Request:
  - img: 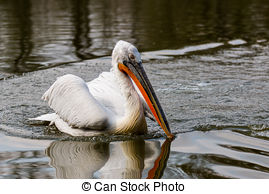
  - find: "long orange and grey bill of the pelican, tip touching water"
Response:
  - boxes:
[118,61,174,138]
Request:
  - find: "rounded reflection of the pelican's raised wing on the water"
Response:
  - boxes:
[46,141,109,178]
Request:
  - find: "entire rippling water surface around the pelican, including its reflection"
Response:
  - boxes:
[0,0,269,178]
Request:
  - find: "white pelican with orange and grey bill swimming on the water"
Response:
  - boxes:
[35,40,173,138]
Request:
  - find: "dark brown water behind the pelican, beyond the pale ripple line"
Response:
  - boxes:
[0,0,269,76]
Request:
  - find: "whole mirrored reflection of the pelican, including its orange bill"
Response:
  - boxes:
[46,139,171,178]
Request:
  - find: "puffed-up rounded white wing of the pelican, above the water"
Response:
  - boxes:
[42,74,109,129]
